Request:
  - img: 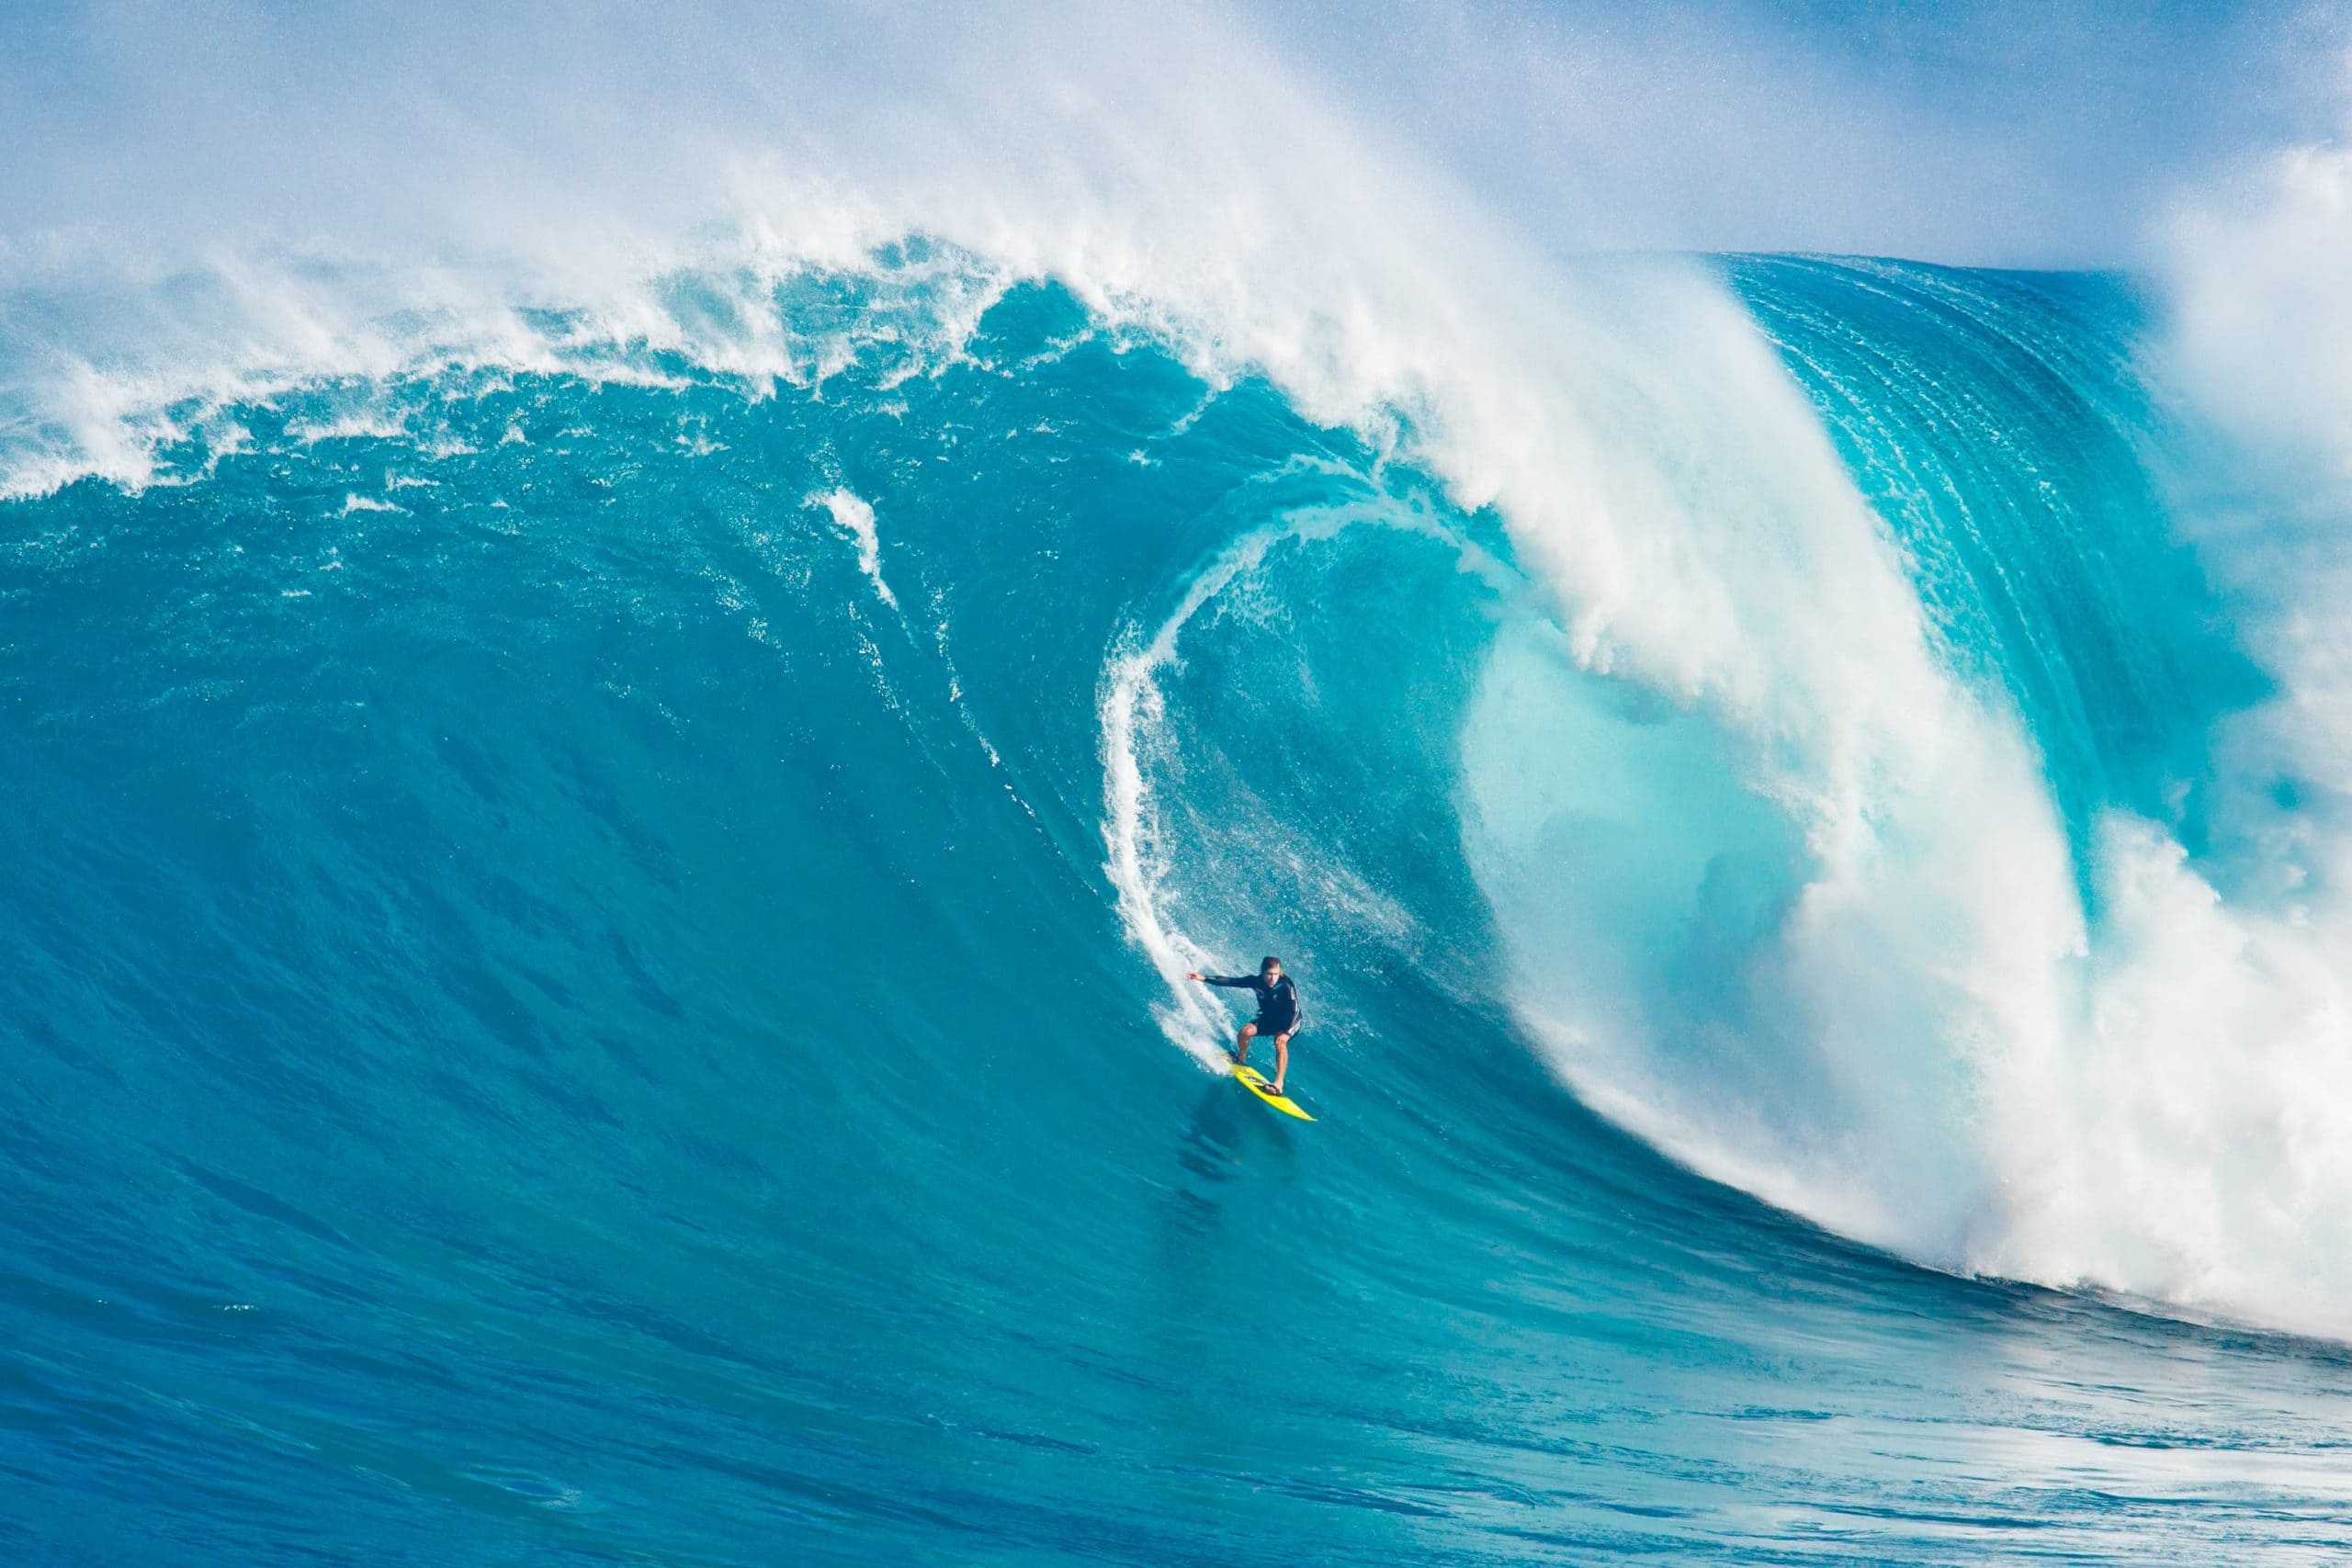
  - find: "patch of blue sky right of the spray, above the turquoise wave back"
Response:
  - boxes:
[1289,0,2352,265]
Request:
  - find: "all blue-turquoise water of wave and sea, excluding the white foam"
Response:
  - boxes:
[0,259,2352,1565]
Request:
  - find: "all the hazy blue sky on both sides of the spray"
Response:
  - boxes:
[0,0,2347,265]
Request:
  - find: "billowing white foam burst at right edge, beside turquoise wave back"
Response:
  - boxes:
[1947,138,2352,1336]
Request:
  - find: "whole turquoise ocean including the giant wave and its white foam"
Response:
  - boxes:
[0,237,2352,1568]
